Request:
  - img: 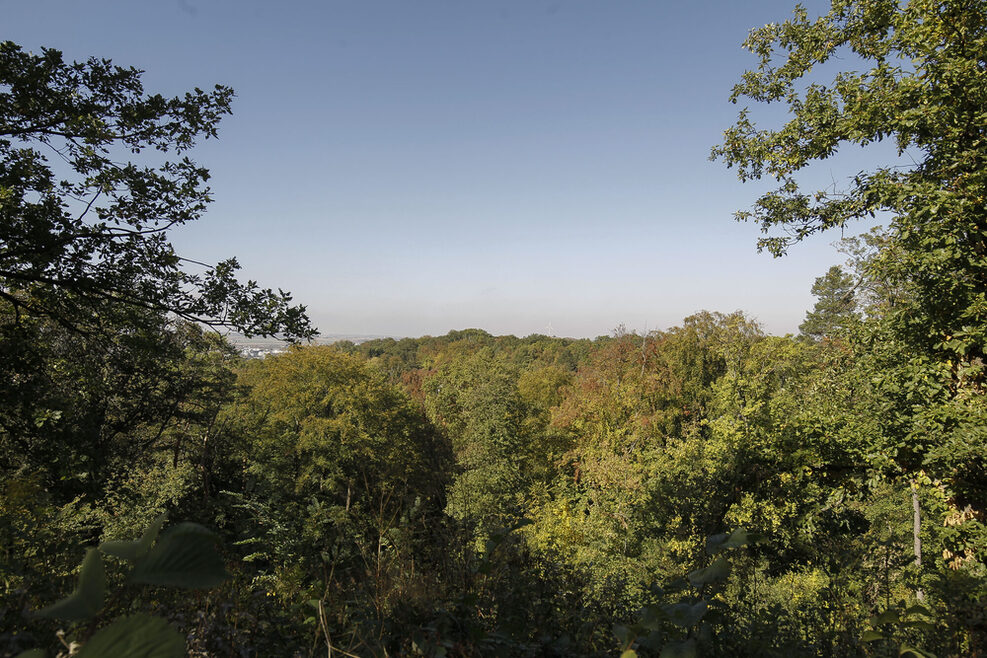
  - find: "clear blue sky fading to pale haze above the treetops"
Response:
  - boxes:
[0,0,888,337]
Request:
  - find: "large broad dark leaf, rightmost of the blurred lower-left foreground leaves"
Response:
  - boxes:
[130,523,228,589]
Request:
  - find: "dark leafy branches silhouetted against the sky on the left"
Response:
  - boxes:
[0,41,315,338]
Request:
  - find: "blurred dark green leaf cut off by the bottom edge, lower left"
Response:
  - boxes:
[76,614,185,658]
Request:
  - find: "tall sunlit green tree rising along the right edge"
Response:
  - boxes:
[713,0,987,642]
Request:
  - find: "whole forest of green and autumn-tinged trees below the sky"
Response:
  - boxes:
[0,0,987,658]
